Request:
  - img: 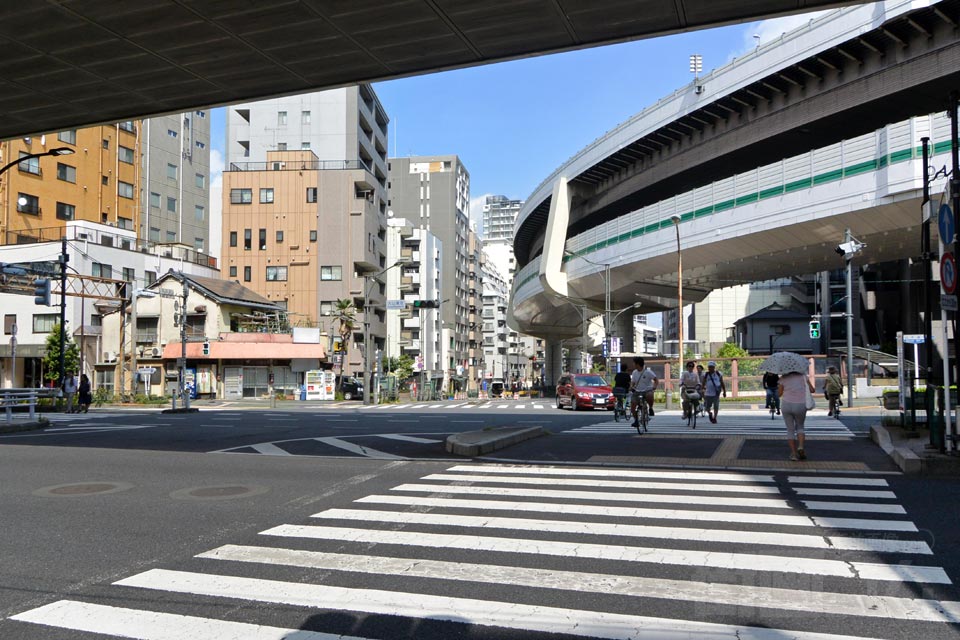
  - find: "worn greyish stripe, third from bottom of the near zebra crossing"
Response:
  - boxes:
[206,545,960,623]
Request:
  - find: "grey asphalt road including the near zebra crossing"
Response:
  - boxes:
[0,401,960,640]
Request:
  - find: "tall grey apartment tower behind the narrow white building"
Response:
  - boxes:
[388,155,470,389]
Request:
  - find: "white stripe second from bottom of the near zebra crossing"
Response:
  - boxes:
[115,569,892,640]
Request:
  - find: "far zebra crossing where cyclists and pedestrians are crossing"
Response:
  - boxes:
[564,409,857,438]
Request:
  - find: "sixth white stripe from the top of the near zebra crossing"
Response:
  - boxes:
[261,524,952,584]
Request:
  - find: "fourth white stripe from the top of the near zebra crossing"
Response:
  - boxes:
[355,495,917,532]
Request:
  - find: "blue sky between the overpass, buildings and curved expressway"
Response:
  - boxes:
[211,9,813,228]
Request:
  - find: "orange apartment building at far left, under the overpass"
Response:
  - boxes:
[0,121,143,244]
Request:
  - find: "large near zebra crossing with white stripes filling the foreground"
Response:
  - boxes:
[11,464,960,640]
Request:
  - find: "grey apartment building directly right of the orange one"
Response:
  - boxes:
[138,110,212,253]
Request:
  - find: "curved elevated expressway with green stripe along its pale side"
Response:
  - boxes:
[511,0,960,366]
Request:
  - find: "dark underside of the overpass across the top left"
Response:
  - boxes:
[0,0,862,139]
